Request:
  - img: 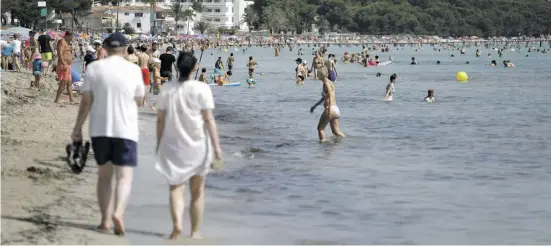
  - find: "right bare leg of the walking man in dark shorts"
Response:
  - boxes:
[111,165,133,236]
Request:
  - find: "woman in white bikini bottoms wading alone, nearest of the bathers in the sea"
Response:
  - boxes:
[312,67,344,142]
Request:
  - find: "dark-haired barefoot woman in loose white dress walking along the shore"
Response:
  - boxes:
[155,53,222,239]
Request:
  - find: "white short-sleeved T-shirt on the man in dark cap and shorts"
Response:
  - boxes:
[81,56,145,142]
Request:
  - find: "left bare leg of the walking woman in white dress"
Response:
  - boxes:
[169,184,185,240]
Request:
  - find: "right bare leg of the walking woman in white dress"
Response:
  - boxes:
[189,175,205,239]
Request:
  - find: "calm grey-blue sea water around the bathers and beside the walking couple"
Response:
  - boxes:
[118,44,551,244]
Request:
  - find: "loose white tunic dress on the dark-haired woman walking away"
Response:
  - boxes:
[155,80,214,185]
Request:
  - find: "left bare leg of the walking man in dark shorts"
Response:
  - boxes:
[96,162,113,232]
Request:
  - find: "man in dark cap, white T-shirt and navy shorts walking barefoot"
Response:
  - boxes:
[72,32,145,235]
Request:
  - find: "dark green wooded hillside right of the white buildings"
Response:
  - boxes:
[244,0,551,37]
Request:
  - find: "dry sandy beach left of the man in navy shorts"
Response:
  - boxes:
[1,72,129,244]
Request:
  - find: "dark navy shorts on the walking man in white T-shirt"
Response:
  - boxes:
[92,137,138,167]
